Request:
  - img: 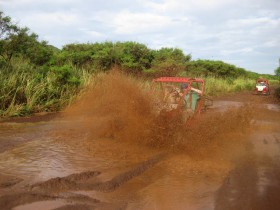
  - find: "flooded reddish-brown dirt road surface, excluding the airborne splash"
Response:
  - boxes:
[0,90,280,210]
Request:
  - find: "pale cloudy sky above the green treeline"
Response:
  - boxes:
[0,0,280,74]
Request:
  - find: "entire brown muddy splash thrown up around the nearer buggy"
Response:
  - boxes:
[62,72,252,158]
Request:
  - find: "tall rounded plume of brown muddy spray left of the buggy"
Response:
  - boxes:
[62,72,154,144]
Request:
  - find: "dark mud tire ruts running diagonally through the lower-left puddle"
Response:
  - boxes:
[0,153,168,210]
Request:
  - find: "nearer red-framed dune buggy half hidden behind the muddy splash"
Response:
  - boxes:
[153,77,213,124]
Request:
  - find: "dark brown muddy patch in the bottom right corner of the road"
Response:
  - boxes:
[215,134,280,210]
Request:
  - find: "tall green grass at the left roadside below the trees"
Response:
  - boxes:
[0,59,92,117]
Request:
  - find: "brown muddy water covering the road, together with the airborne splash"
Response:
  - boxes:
[0,74,280,210]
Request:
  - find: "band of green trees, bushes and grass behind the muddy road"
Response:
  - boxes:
[0,11,279,117]
